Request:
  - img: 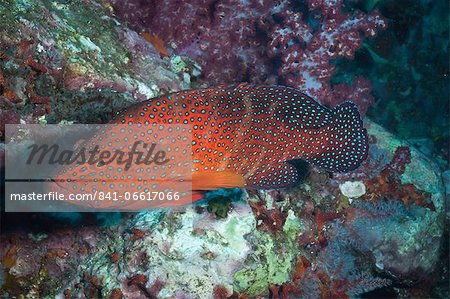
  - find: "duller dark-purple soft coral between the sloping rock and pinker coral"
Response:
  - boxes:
[108,0,283,84]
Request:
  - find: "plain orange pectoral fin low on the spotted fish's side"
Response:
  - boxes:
[192,171,245,190]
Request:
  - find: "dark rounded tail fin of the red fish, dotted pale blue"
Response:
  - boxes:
[307,101,369,172]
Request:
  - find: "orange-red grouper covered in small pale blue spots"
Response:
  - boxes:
[49,84,368,209]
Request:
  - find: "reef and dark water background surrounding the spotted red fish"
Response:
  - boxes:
[0,0,450,298]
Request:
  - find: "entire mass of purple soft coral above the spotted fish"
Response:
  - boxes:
[107,0,386,114]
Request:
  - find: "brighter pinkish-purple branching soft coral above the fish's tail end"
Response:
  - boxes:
[269,0,386,114]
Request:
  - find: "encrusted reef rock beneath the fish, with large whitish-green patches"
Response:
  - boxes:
[0,122,445,298]
